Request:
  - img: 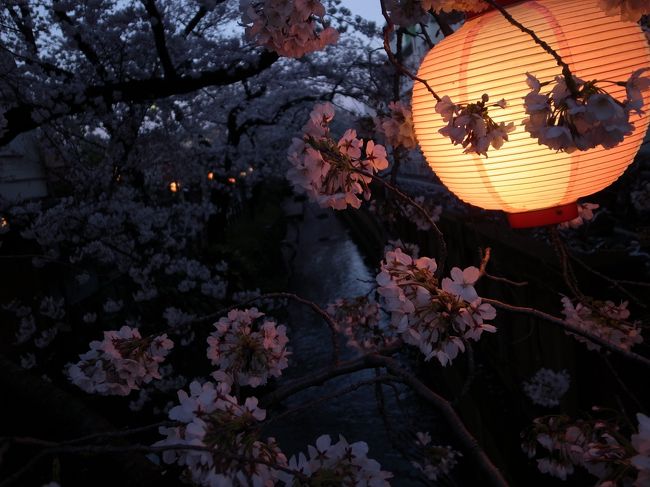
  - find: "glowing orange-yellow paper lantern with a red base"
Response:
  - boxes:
[412,0,650,227]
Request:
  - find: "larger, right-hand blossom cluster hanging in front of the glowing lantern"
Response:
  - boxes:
[524,68,650,153]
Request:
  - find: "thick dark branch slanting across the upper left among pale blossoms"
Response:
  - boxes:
[0,51,278,147]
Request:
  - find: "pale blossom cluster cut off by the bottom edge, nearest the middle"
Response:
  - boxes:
[277,435,393,487]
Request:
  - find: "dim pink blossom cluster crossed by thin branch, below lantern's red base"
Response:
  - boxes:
[562,296,643,350]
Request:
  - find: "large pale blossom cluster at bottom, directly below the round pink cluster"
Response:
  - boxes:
[154,381,286,487]
